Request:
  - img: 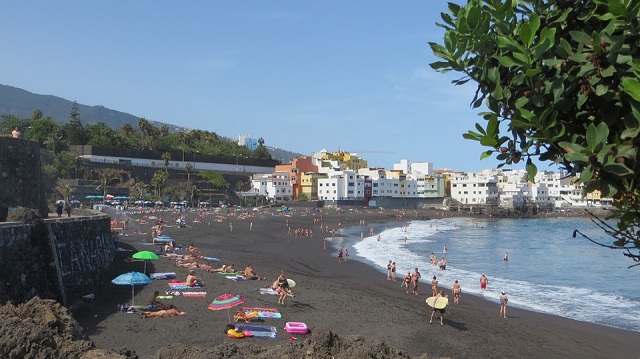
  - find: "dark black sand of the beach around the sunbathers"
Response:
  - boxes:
[73,209,640,358]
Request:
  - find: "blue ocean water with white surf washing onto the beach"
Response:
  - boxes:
[332,218,640,331]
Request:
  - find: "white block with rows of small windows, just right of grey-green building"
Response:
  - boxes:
[450,173,500,205]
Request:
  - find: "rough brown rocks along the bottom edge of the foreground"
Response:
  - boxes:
[0,297,436,359]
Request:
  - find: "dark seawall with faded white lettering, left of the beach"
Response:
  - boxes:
[0,215,115,305]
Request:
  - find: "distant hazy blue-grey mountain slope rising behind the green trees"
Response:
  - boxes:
[0,85,300,163]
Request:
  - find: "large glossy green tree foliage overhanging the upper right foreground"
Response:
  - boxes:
[430,0,640,261]
